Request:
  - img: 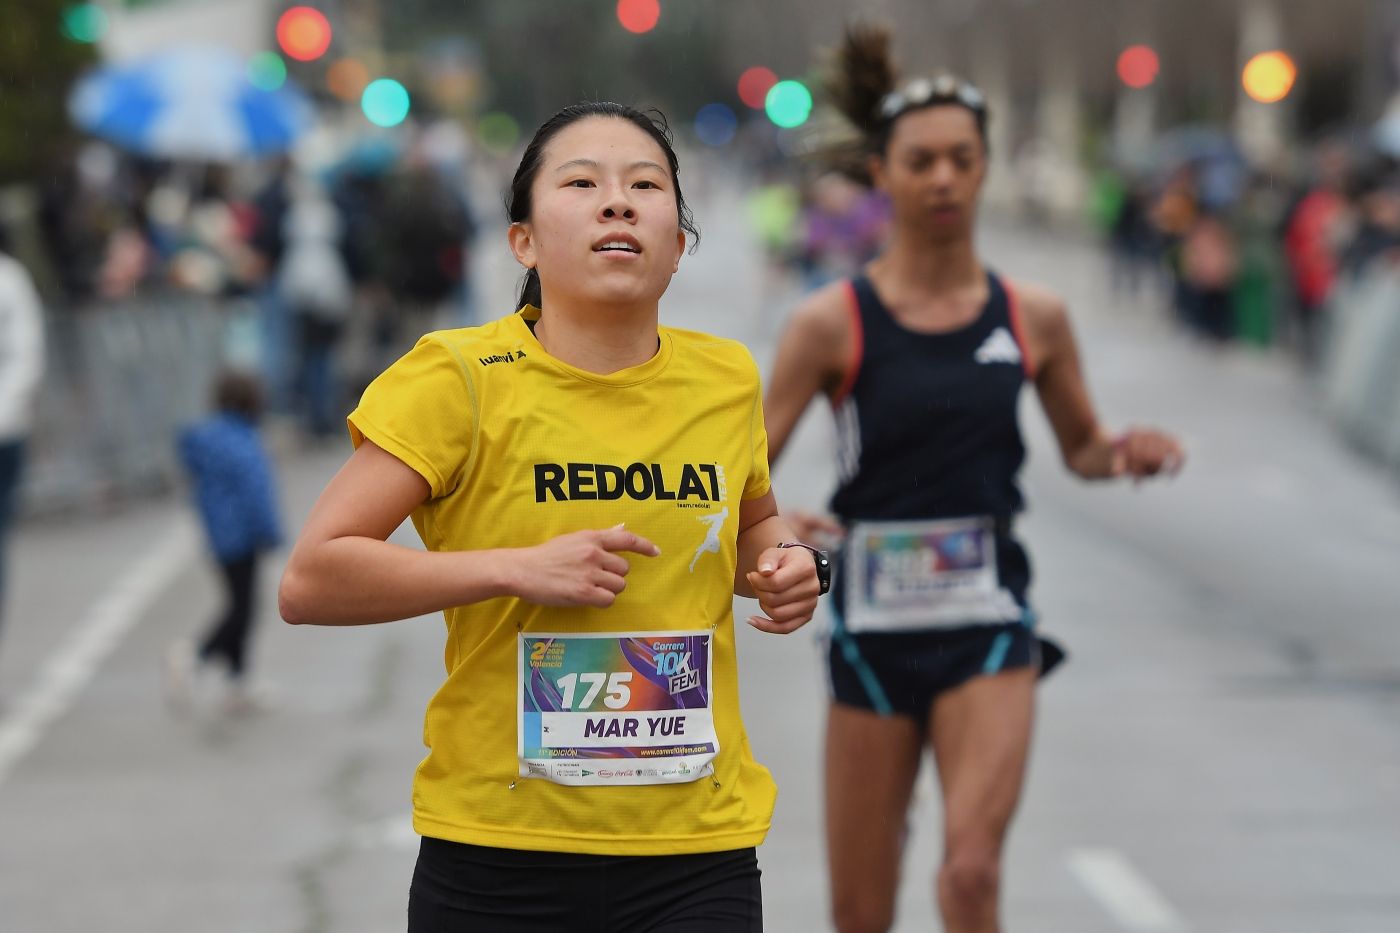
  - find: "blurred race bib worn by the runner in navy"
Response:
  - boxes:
[843,517,1022,632]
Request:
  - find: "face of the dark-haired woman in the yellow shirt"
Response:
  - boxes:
[510,116,686,304]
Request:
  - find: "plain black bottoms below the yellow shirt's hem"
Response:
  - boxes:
[409,836,763,933]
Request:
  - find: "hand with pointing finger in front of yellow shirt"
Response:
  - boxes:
[508,525,661,609]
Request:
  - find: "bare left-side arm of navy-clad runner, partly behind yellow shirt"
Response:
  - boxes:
[763,282,854,464]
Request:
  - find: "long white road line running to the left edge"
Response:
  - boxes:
[0,520,197,785]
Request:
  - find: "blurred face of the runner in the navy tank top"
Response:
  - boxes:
[871,105,987,241]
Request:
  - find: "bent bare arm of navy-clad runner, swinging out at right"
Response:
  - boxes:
[1018,286,1184,479]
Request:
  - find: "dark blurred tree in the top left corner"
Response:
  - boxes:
[0,0,97,185]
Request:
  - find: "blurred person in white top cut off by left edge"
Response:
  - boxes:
[0,218,43,652]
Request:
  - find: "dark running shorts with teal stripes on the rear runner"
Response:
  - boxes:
[827,622,1064,728]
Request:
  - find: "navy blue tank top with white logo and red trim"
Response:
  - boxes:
[832,272,1030,527]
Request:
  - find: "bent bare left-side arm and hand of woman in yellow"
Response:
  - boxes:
[277,441,658,625]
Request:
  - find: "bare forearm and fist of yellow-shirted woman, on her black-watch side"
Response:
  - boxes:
[734,489,822,635]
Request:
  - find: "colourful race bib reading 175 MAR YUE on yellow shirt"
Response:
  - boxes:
[518,632,720,786]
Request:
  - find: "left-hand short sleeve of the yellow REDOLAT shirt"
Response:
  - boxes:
[347,335,479,499]
